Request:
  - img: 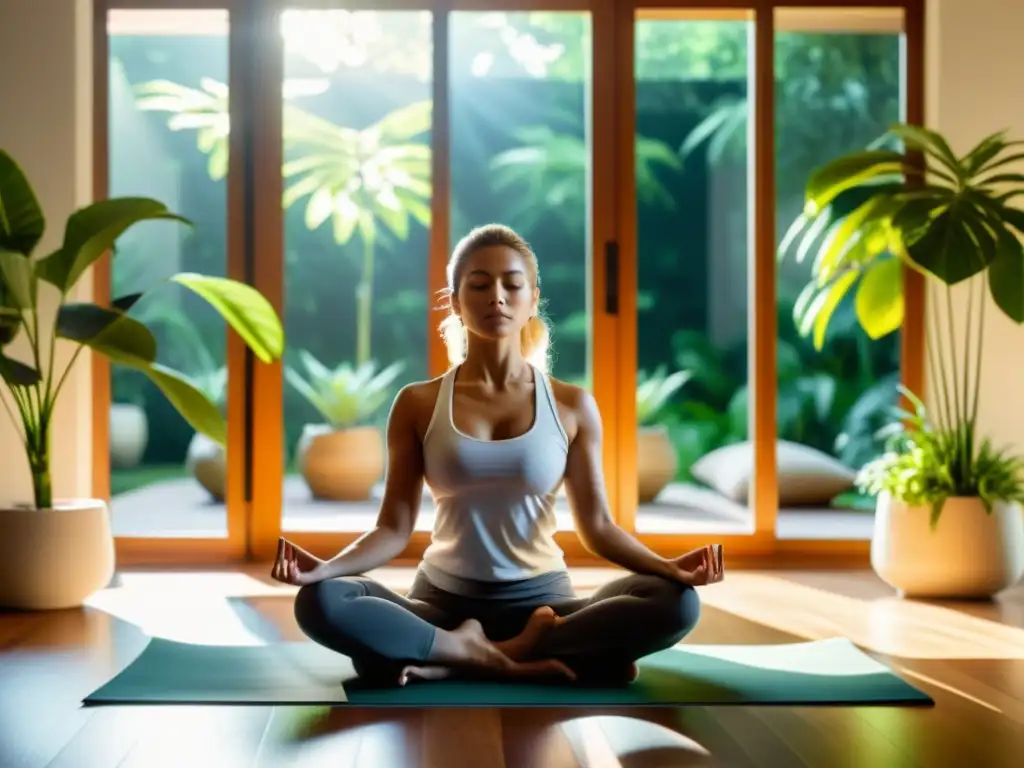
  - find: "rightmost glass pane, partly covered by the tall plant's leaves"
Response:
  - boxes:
[775,9,903,540]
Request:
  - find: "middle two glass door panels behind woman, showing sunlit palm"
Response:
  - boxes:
[254,0,615,565]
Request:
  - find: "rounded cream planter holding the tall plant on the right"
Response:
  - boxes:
[871,495,1024,599]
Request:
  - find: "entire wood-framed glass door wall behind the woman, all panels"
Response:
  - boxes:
[95,0,923,559]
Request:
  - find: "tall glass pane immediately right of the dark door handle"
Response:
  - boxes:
[635,9,754,534]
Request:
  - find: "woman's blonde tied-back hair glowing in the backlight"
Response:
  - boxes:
[440,224,551,373]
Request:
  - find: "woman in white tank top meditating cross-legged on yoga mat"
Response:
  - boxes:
[272,225,722,685]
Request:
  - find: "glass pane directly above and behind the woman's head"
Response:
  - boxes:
[448,11,592,529]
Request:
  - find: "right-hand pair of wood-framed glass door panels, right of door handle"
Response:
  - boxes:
[617,0,923,553]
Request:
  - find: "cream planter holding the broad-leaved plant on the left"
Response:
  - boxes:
[0,499,114,610]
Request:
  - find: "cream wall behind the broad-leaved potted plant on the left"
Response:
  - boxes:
[0,0,92,506]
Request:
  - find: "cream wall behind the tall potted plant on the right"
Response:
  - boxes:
[926,0,1024,450]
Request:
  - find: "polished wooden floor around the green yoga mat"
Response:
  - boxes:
[0,569,1024,768]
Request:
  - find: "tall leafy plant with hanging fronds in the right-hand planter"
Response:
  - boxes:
[780,124,1024,519]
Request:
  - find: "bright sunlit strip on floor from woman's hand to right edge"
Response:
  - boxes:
[701,572,1024,659]
